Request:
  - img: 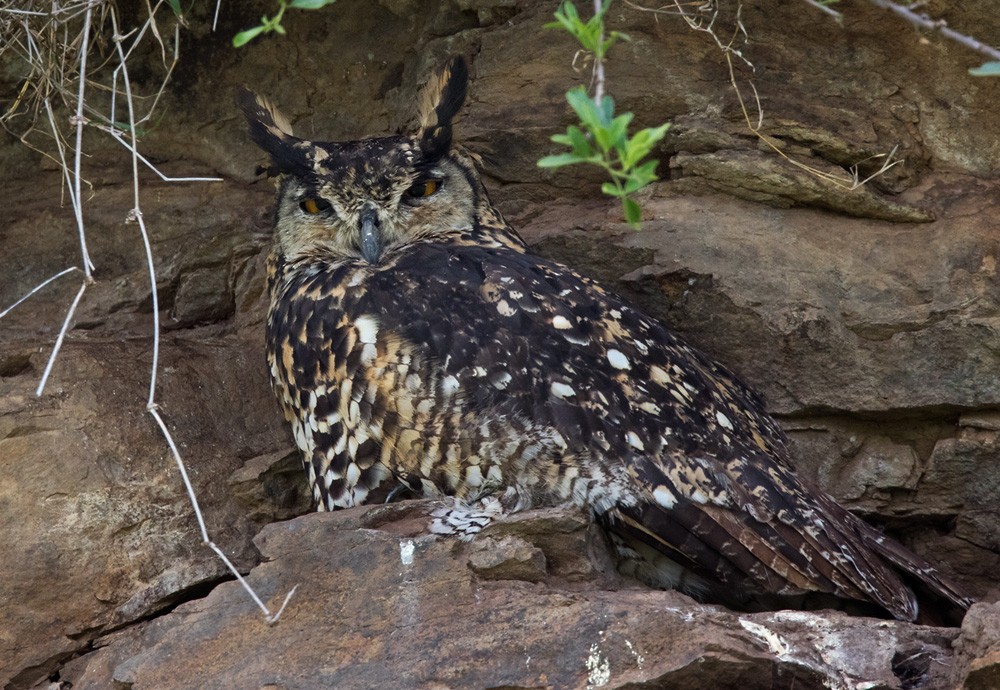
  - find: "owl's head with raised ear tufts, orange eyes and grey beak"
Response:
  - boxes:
[238,57,482,264]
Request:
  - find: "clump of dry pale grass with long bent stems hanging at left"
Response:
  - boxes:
[0,0,295,623]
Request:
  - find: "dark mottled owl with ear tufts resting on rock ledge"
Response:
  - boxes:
[239,58,971,620]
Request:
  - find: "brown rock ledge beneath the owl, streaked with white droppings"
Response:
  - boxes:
[54,502,956,690]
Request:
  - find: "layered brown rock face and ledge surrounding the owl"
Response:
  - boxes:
[0,0,1000,690]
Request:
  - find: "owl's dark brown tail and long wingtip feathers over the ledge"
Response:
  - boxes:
[605,486,972,622]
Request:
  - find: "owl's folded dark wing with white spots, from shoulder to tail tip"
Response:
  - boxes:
[334,238,968,620]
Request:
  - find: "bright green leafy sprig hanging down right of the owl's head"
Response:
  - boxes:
[538,0,670,229]
